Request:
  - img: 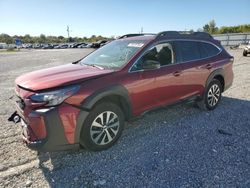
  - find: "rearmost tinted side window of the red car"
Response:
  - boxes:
[199,42,220,58]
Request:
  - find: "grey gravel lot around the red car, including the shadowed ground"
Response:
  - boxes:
[0,49,250,187]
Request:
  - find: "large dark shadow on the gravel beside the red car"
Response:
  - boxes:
[38,97,250,187]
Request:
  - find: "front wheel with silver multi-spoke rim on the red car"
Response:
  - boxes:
[80,102,124,151]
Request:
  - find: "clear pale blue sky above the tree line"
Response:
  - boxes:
[0,0,250,37]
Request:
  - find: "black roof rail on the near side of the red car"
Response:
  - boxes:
[155,31,213,39]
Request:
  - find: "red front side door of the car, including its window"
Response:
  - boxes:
[129,42,181,113]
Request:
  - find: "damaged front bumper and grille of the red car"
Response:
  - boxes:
[8,86,89,151]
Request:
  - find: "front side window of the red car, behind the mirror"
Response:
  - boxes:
[131,43,174,71]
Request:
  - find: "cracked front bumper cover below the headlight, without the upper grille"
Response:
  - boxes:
[9,104,88,151]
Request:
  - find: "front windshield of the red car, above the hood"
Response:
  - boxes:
[80,40,146,69]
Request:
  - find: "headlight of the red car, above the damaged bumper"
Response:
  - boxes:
[30,85,80,106]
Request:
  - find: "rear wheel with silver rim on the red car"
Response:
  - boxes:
[197,79,222,110]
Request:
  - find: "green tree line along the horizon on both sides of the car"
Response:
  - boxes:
[0,20,250,44]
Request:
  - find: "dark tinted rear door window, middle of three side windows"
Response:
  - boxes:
[176,41,200,62]
